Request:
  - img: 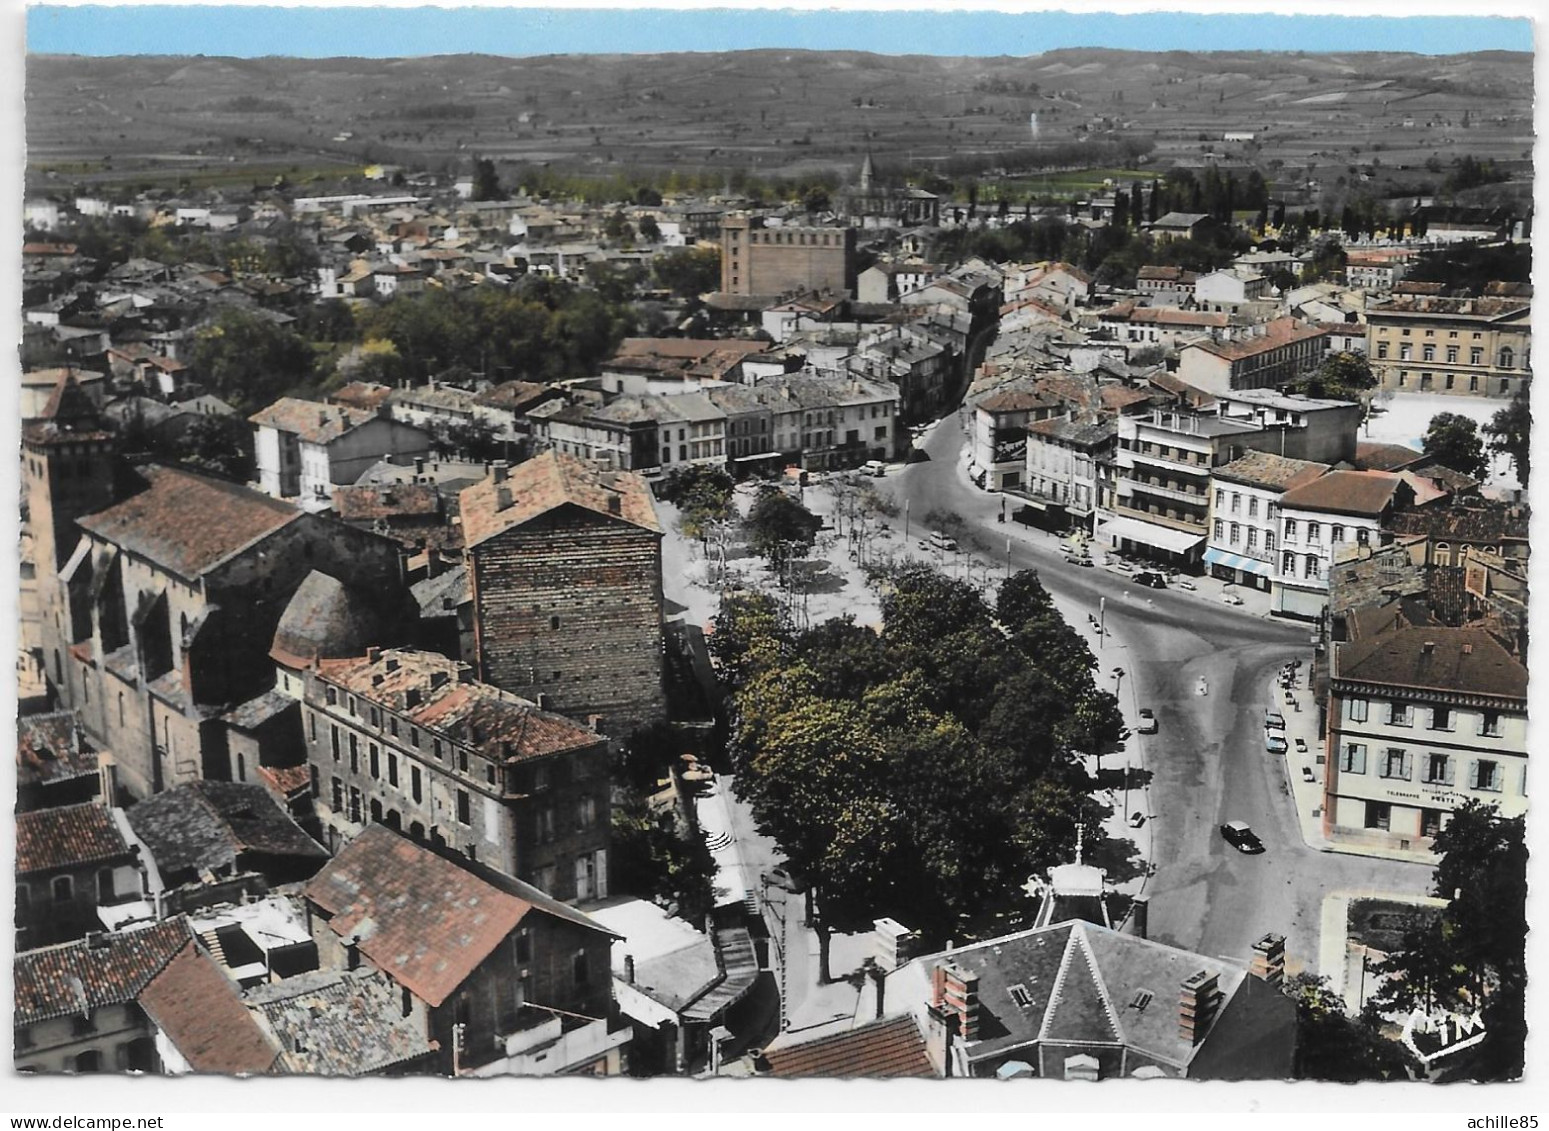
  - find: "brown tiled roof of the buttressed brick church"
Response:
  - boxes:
[79,465,302,581]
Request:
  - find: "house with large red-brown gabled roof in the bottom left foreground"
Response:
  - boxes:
[305,824,629,1075]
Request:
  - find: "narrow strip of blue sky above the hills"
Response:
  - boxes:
[26,5,1532,57]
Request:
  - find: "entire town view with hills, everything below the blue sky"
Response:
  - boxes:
[14,42,1534,1081]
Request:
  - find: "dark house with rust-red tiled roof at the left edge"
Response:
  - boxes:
[15,801,141,950]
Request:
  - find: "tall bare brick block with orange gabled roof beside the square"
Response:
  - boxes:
[460,452,666,736]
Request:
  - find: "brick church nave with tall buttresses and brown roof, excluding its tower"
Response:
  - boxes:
[65,466,403,798]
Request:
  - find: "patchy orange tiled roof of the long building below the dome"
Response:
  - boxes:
[318,648,606,762]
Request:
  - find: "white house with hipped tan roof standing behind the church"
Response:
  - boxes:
[248,397,431,505]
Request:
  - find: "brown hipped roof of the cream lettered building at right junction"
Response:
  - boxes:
[1335,626,1527,705]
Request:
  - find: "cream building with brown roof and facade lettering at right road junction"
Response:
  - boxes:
[1323,617,1527,851]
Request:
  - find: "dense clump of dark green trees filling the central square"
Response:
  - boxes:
[711,567,1126,976]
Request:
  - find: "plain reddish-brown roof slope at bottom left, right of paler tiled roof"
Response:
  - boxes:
[139,939,279,1075]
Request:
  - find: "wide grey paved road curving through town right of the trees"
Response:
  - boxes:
[878,418,1430,968]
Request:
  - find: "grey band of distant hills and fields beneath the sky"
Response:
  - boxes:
[26,50,1534,190]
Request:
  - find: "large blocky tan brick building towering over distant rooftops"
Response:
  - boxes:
[720,214,855,294]
